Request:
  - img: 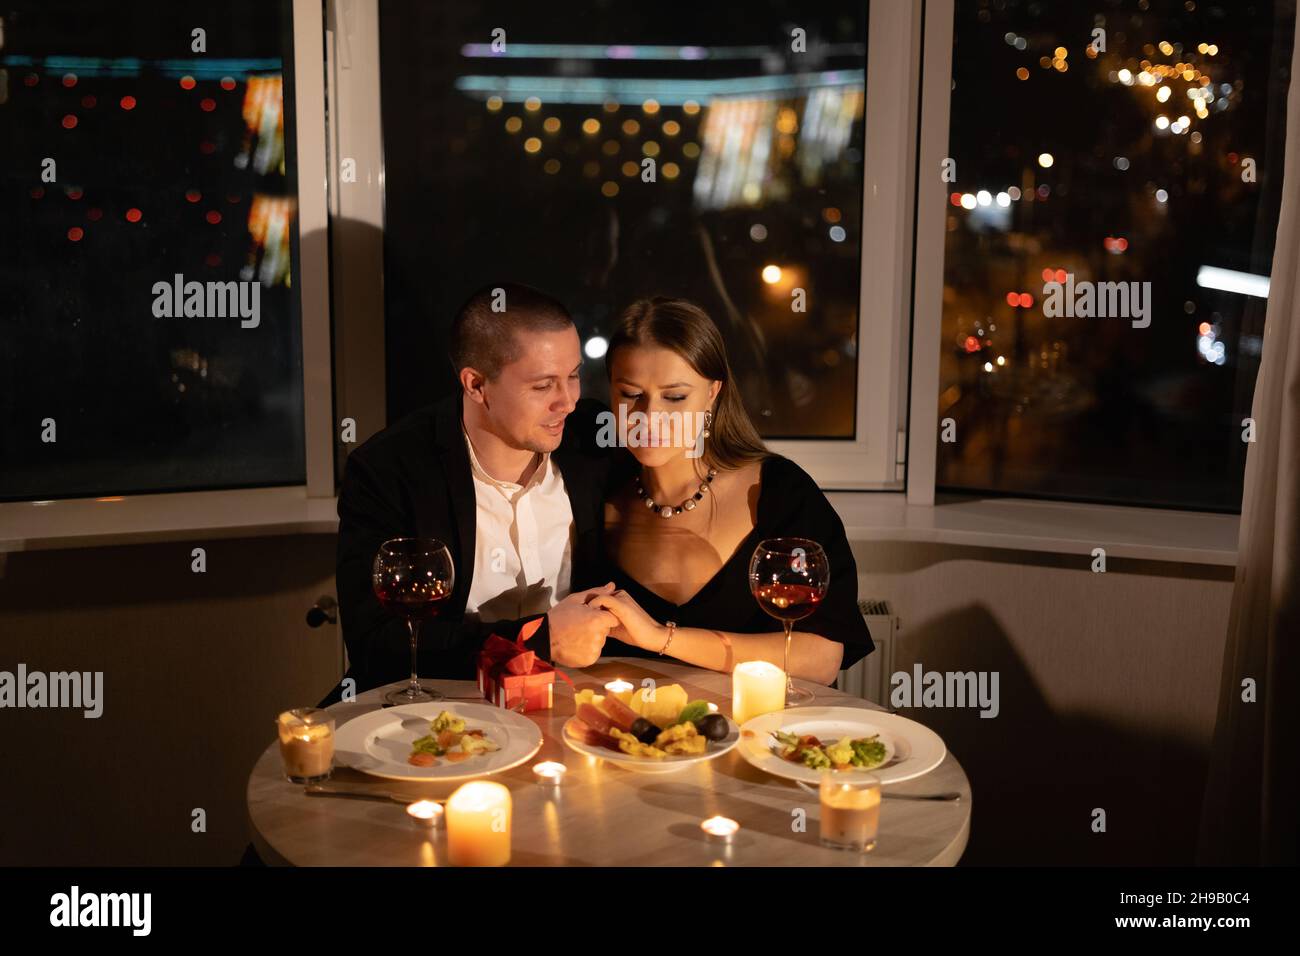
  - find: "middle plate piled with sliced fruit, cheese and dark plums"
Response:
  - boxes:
[564,684,740,774]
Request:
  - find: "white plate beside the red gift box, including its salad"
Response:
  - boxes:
[334,701,542,780]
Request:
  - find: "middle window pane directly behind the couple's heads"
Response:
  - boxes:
[380,1,873,442]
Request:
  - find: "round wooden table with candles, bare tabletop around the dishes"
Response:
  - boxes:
[248,658,971,866]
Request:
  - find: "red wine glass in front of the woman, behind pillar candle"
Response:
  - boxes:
[749,537,831,706]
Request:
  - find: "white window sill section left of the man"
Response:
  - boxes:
[0,485,338,553]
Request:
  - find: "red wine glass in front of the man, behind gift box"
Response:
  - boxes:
[371,537,456,704]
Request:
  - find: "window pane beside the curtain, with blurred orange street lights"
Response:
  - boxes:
[936,0,1295,511]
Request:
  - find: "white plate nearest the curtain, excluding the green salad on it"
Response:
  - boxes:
[740,708,948,783]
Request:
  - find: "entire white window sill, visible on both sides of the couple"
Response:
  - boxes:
[0,486,1239,567]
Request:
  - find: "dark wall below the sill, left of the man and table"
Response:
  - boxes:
[0,535,342,865]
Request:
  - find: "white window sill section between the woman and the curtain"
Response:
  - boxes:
[827,492,1240,567]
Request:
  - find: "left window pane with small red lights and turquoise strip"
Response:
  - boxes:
[0,0,306,501]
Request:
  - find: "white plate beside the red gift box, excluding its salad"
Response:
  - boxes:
[334,700,542,782]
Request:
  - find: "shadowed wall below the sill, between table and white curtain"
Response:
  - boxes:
[854,542,1232,865]
